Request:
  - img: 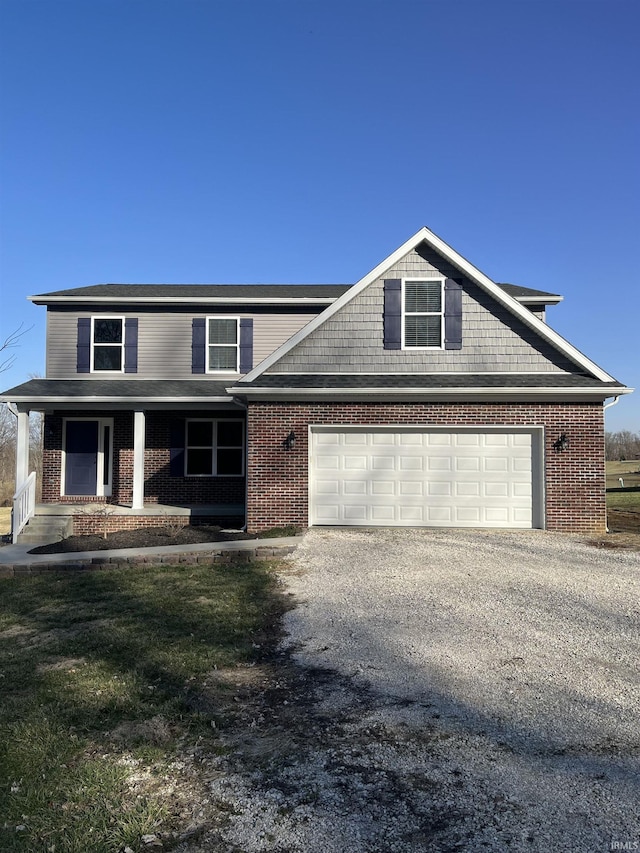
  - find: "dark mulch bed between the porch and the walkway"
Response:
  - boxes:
[29,524,255,554]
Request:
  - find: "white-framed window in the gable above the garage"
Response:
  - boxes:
[402,278,444,349]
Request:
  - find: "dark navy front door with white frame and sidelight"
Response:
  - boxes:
[63,420,113,495]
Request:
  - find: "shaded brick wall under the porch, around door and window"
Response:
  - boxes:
[42,410,245,504]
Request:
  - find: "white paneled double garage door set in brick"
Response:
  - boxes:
[309,427,541,527]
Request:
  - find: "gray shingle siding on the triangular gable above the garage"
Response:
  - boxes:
[268,248,576,373]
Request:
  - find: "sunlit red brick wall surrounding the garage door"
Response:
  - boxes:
[247,403,606,533]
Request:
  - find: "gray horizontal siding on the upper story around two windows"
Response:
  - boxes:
[47,308,314,379]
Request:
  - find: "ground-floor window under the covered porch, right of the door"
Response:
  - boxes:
[185,419,244,477]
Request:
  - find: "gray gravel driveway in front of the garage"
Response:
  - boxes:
[195,529,640,853]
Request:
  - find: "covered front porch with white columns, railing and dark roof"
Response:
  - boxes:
[0,380,246,541]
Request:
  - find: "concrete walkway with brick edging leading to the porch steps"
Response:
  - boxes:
[0,536,302,575]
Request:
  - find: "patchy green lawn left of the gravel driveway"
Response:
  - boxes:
[0,562,283,853]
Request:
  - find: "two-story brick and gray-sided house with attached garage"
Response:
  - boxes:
[2,228,631,532]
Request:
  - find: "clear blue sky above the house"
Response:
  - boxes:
[0,0,640,432]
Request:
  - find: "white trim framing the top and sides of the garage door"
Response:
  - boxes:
[307,424,546,530]
